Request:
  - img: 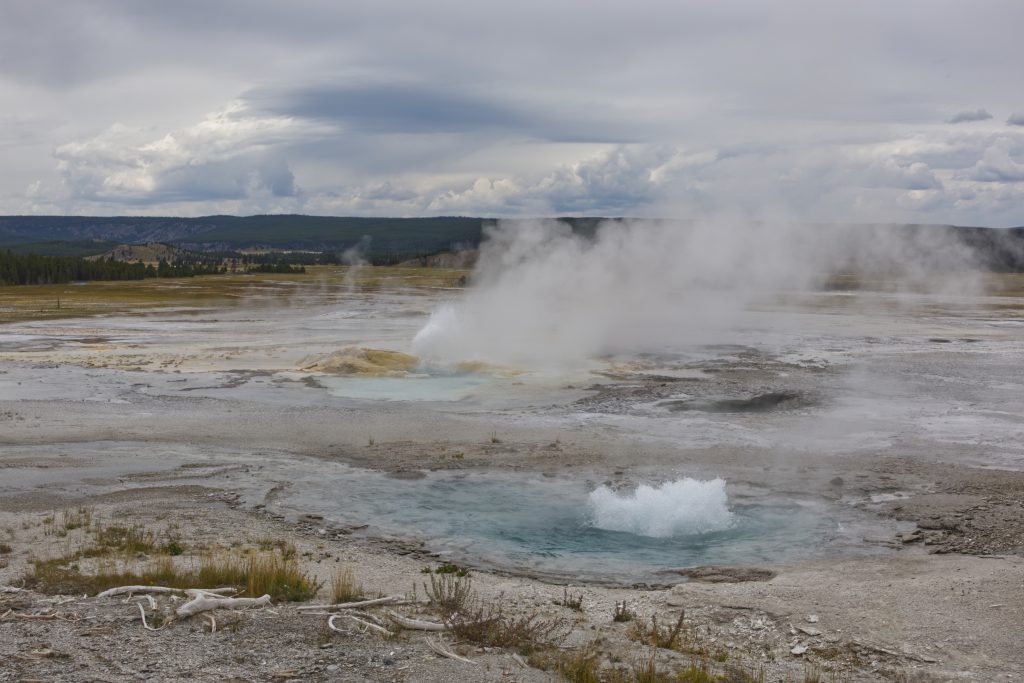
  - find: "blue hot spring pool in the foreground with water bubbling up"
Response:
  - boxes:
[245,464,897,583]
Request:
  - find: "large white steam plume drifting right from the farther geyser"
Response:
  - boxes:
[413,220,975,366]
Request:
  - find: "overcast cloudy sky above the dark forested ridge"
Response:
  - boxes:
[0,0,1024,226]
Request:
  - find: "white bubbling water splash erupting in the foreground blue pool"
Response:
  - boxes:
[589,477,733,539]
